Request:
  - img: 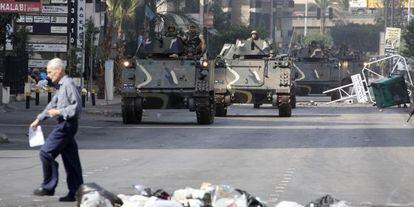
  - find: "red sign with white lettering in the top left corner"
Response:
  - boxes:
[0,1,42,14]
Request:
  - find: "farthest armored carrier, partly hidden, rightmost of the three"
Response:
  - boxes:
[293,47,342,100]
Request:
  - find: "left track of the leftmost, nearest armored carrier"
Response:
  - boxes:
[122,98,142,124]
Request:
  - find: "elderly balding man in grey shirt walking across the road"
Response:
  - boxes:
[30,58,83,202]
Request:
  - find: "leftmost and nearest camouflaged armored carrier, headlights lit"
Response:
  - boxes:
[122,37,215,124]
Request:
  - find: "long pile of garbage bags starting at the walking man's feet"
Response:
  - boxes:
[76,183,267,207]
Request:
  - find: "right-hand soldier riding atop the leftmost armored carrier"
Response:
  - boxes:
[185,25,206,57]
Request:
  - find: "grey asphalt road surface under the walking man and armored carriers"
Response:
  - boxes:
[0,99,414,206]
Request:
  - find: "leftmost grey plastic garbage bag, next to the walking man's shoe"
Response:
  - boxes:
[76,183,123,207]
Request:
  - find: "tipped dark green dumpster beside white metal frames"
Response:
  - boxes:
[371,75,410,108]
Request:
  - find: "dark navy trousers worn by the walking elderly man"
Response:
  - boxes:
[40,119,83,196]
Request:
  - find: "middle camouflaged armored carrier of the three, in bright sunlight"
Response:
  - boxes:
[214,38,294,117]
